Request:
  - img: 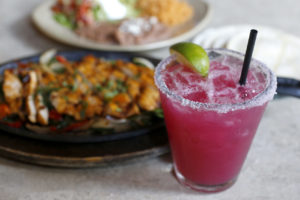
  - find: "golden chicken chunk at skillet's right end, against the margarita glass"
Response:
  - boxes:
[138,86,159,111]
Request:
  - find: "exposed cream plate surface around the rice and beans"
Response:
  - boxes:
[32,0,211,51]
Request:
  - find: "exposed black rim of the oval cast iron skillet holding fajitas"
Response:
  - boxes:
[0,50,165,143]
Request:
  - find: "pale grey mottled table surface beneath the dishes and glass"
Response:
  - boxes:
[0,0,300,200]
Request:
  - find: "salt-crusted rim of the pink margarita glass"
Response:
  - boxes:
[154,48,277,113]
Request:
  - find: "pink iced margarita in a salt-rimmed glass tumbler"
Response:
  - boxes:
[155,49,276,191]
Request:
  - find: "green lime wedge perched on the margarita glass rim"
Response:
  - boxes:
[170,42,209,76]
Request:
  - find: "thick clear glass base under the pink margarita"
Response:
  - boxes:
[174,166,236,193]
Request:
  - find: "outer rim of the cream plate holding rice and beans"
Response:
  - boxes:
[31,0,212,52]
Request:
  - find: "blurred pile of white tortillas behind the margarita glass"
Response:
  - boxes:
[193,25,300,79]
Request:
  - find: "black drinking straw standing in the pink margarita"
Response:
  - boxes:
[239,29,257,85]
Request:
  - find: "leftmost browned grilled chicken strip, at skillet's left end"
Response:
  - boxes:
[2,70,23,113]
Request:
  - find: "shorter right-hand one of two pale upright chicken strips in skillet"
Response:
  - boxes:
[35,94,49,125]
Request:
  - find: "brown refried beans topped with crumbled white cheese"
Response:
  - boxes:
[75,17,172,46]
